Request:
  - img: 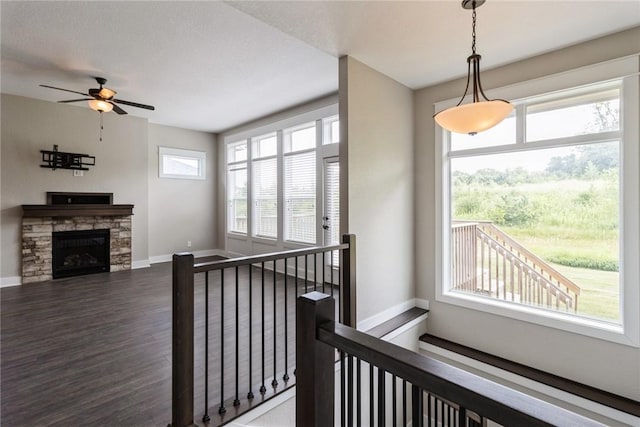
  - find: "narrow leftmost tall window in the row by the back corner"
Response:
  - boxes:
[227,141,247,234]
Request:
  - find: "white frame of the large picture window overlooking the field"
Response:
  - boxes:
[434,55,640,347]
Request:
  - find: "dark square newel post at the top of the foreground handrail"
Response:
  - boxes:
[296,291,335,427]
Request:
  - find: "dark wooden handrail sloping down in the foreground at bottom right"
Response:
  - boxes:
[318,320,603,427]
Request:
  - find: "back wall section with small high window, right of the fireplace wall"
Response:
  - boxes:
[148,124,218,262]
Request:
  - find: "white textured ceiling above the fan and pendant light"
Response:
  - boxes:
[0,0,640,132]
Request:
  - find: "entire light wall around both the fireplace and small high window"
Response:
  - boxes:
[0,94,220,284]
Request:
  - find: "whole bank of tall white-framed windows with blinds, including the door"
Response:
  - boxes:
[225,104,339,254]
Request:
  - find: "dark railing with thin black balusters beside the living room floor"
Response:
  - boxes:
[170,234,356,427]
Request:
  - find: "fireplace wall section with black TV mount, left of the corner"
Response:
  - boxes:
[0,94,149,281]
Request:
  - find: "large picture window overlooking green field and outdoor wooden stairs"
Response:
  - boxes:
[437,58,639,345]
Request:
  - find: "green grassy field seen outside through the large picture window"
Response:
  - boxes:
[453,177,620,323]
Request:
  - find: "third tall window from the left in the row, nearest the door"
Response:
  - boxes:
[283,122,317,243]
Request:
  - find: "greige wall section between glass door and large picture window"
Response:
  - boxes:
[339,57,414,320]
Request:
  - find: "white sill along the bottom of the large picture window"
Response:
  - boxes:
[436,292,640,348]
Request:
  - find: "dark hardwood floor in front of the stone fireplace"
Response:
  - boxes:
[0,263,337,427]
